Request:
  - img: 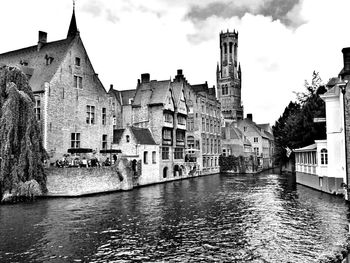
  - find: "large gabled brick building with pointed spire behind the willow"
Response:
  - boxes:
[0,9,117,162]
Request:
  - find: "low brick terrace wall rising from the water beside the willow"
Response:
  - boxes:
[46,167,133,196]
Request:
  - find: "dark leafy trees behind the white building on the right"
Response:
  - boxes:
[272,71,326,164]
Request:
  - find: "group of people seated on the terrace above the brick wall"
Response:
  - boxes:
[54,156,117,168]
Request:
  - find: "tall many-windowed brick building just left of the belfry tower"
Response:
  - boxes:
[173,69,221,174]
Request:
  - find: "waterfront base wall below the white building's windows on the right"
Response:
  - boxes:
[296,172,344,194]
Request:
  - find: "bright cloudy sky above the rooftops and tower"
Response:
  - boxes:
[0,0,350,124]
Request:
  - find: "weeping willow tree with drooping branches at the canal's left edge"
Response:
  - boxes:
[0,65,47,201]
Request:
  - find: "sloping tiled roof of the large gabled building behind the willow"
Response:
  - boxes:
[0,38,74,92]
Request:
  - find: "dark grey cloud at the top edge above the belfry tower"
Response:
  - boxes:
[185,0,303,27]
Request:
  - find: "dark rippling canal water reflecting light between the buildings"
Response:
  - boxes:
[0,172,350,262]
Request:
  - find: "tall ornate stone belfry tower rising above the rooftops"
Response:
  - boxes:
[216,30,243,122]
